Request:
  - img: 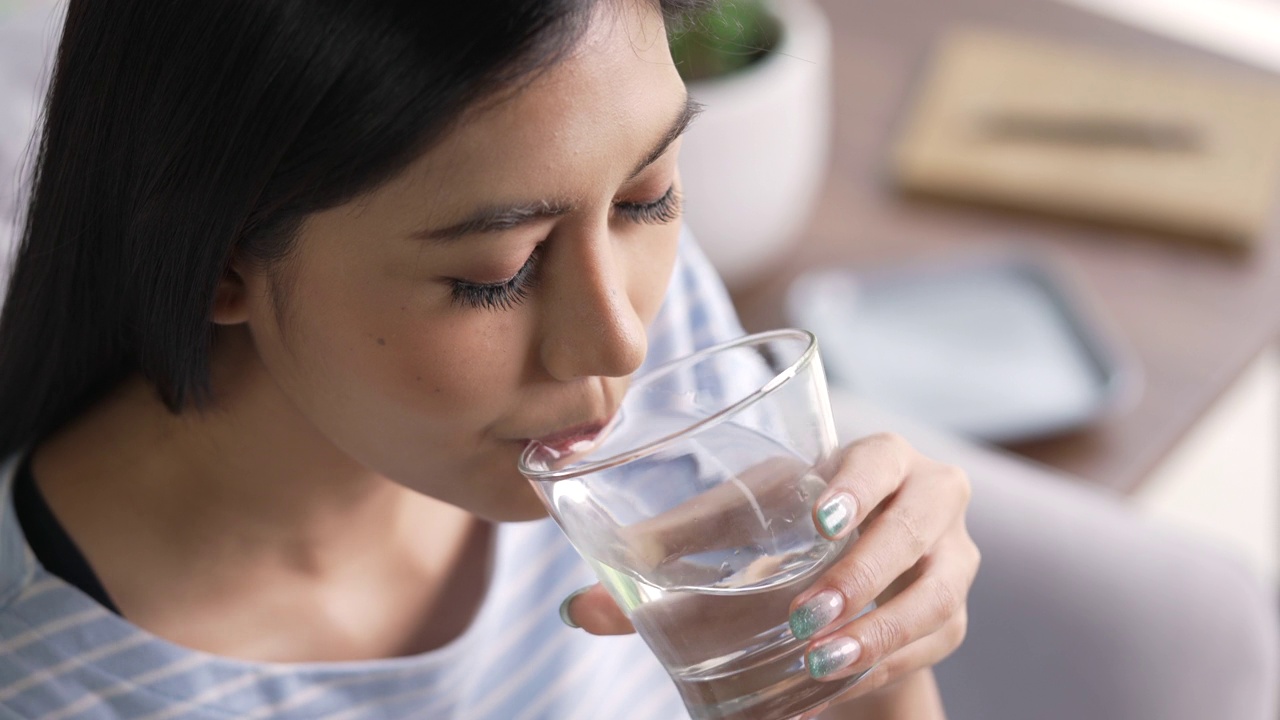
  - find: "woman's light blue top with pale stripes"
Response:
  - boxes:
[0,237,741,720]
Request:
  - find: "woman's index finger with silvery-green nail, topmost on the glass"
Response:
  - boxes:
[813,433,916,539]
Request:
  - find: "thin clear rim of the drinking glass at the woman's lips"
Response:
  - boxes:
[518,328,818,482]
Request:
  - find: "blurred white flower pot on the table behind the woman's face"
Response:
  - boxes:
[680,0,831,286]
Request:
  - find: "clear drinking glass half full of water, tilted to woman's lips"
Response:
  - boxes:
[520,331,859,720]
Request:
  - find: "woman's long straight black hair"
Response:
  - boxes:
[0,0,698,456]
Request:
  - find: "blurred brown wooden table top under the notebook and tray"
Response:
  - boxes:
[733,0,1280,492]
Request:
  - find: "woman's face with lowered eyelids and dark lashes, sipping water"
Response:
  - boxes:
[230,3,689,520]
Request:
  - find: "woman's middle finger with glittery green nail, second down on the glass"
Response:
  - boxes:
[791,465,972,639]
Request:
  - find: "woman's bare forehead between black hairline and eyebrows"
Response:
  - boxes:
[360,0,684,215]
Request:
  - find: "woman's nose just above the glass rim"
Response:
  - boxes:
[540,228,648,380]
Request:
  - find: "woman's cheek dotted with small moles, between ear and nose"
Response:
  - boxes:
[247,257,529,458]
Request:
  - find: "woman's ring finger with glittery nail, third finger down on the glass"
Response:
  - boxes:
[805,536,978,679]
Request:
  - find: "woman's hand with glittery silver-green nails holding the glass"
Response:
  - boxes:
[562,434,979,702]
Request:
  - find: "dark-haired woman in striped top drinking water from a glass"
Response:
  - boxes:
[0,0,978,720]
